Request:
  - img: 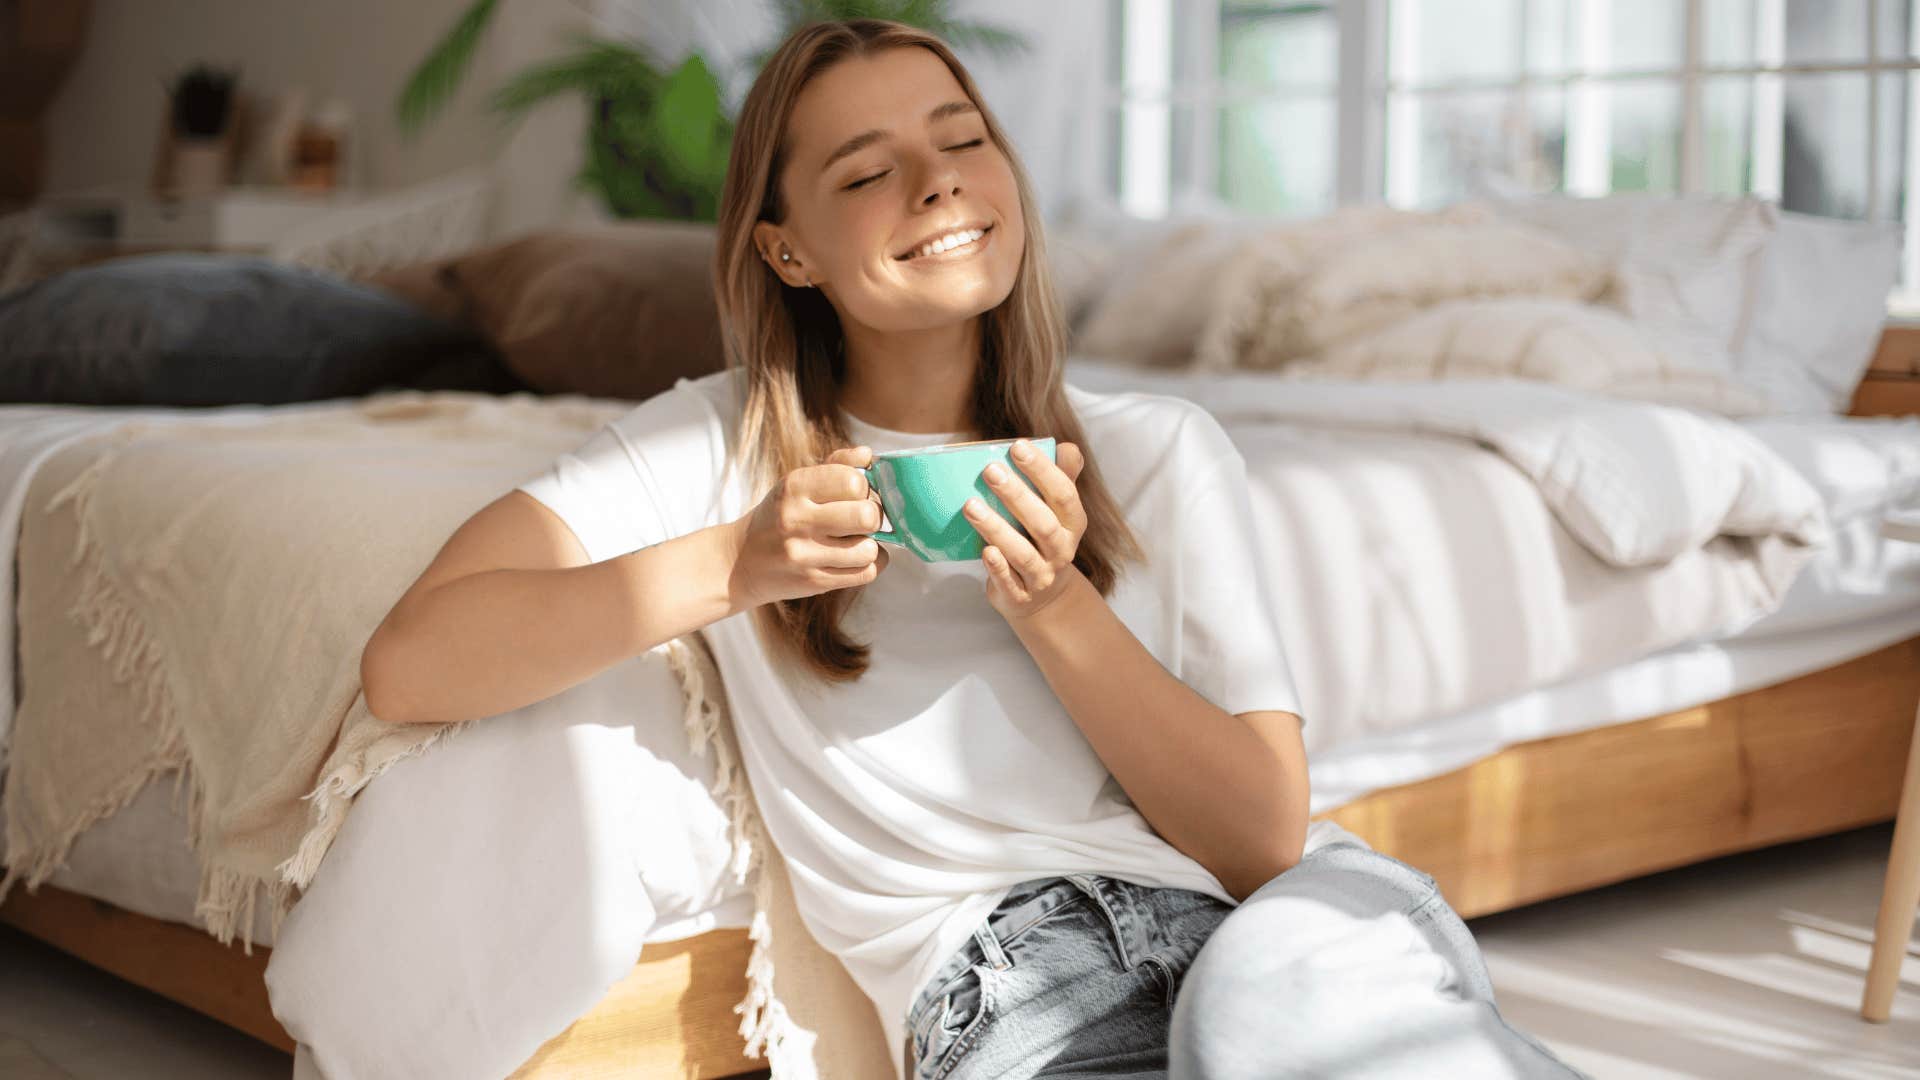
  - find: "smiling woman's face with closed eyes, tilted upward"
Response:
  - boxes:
[756,48,1025,332]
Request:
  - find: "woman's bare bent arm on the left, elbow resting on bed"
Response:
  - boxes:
[361,490,739,723]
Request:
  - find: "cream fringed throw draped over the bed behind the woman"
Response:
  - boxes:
[0,392,891,1080]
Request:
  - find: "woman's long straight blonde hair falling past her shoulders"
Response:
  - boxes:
[714,19,1144,680]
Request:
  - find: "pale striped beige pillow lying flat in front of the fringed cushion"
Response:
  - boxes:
[1284,296,1766,415]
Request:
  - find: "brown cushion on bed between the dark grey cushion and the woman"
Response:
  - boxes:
[397,221,726,402]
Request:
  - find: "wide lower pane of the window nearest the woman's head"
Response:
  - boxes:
[1219,96,1334,215]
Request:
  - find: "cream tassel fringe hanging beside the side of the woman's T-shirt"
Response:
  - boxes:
[657,638,818,1080]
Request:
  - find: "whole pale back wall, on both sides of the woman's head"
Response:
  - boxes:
[46,0,1106,236]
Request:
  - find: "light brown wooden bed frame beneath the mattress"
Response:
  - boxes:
[0,325,1920,1080]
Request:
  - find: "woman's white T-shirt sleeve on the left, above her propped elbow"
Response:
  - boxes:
[516,380,726,563]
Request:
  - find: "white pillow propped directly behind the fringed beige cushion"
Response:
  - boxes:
[1486,192,1780,382]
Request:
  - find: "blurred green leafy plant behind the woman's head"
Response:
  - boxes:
[396,0,1027,221]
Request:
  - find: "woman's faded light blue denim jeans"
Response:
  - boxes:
[906,842,1582,1080]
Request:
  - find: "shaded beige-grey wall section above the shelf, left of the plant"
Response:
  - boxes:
[46,0,589,234]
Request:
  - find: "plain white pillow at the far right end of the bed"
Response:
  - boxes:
[1736,211,1903,413]
